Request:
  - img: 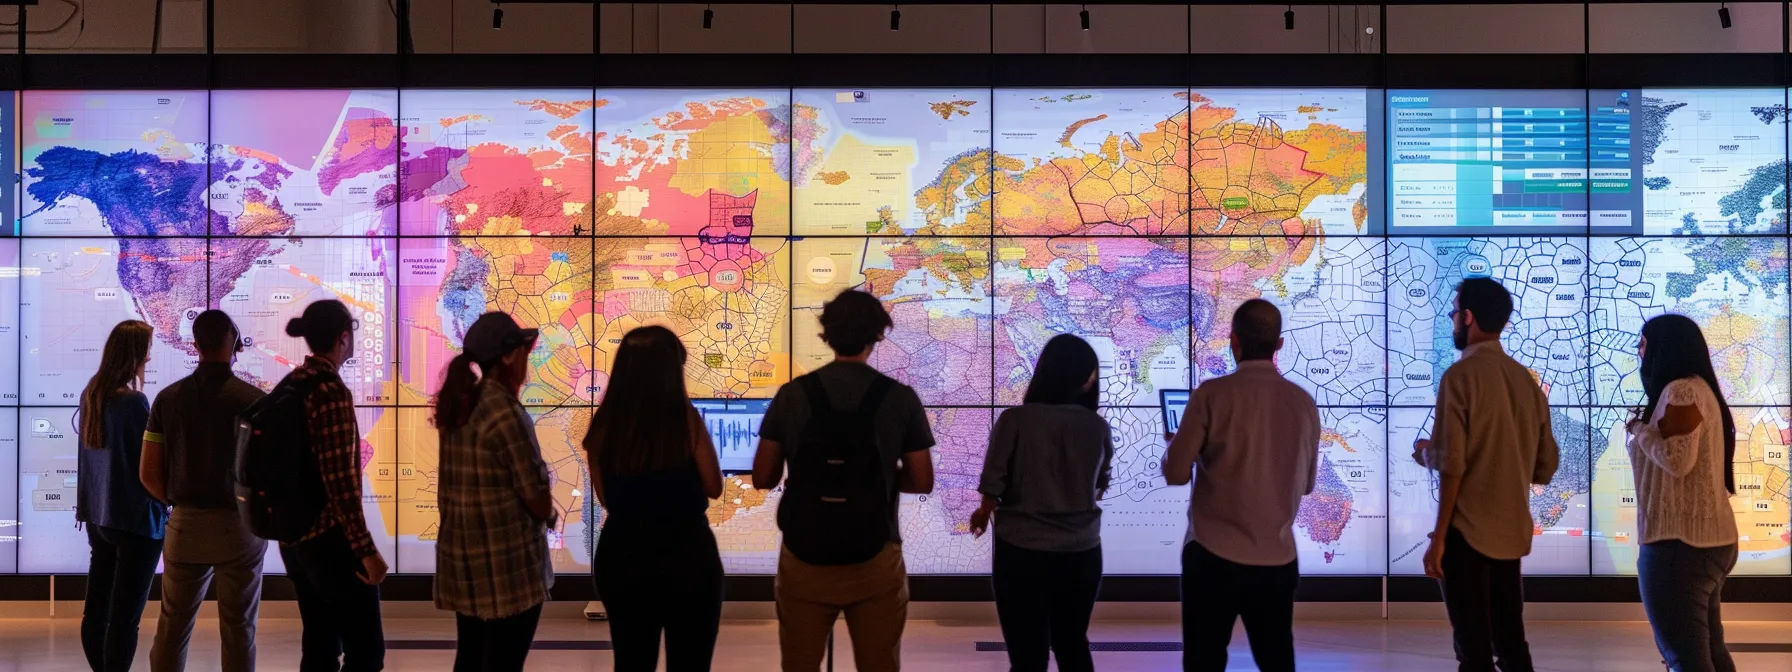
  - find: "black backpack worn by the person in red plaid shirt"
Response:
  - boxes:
[237,375,330,543]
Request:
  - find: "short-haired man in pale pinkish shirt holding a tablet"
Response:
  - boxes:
[1163,299,1319,672]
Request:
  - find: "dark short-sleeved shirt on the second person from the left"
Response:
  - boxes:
[145,362,265,509]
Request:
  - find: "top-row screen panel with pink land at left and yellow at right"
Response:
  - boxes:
[593,90,792,237]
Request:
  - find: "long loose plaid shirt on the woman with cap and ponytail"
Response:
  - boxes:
[435,379,554,620]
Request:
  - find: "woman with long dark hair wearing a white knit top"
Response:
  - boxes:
[1629,315,1736,672]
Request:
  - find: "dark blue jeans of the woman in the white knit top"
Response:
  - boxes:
[1636,541,1736,672]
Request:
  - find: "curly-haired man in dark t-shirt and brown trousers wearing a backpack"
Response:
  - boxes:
[753,290,934,672]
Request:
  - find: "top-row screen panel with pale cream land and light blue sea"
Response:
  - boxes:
[792,90,991,235]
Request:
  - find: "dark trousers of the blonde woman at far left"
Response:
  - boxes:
[81,525,161,672]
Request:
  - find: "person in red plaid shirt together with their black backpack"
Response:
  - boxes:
[237,299,385,672]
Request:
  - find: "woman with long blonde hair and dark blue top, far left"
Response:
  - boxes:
[75,319,168,672]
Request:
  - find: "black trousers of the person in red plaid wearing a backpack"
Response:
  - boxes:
[280,529,385,672]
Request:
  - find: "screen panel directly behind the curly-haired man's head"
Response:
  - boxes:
[794,238,995,405]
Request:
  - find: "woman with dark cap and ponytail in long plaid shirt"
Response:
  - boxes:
[435,312,557,672]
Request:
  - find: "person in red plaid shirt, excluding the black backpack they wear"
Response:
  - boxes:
[276,299,385,672]
